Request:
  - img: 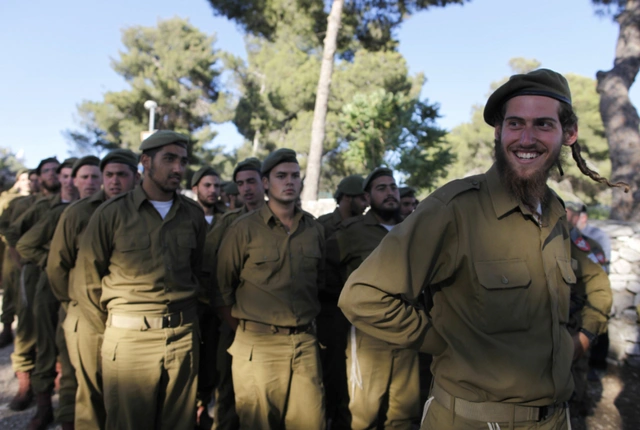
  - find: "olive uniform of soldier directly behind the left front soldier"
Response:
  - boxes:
[47,191,106,429]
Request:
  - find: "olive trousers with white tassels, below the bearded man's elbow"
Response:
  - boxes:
[347,327,420,430]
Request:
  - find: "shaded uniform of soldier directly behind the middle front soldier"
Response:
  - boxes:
[201,206,249,430]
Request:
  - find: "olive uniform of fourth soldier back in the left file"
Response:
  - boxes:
[5,194,61,372]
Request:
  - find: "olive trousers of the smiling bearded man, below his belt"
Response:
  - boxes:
[420,396,569,430]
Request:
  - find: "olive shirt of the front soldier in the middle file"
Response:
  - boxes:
[215,204,324,327]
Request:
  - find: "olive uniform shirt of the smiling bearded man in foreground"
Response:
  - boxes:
[339,165,576,406]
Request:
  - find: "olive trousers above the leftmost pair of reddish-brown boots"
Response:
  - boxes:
[11,264,41,372]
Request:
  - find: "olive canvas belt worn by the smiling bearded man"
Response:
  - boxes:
[431,382,564,423]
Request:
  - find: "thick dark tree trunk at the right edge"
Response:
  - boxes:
[596,0,640,221]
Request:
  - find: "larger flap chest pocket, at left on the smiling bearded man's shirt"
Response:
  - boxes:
[474,259,531,334]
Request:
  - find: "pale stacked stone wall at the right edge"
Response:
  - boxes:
[592,221,640,367]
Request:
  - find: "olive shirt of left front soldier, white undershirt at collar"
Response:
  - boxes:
[79,185,206,315]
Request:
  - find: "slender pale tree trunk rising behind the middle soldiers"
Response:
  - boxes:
[302,0,344,200]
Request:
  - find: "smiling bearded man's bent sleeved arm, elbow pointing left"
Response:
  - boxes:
[338,197,458,354]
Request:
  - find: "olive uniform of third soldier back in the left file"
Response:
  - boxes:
[16,201,76,422]
